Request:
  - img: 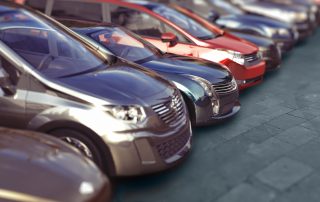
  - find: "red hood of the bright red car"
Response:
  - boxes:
[205,33,258,55]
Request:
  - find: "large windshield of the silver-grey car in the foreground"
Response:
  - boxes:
[0,6,106,78]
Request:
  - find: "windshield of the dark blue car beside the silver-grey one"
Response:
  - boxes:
[89,27,157,62]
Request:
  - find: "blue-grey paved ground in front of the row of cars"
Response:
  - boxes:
[113,30,320,202]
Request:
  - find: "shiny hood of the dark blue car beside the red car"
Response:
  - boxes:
[141,54,232,83]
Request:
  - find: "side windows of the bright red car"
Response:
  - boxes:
[111,5,188,43]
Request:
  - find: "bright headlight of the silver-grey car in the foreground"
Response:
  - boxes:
[109,106,146,123]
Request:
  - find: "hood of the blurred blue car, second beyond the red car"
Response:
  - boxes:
[216,15,291,29]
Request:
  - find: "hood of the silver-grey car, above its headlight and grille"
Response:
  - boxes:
[58,60,171,106]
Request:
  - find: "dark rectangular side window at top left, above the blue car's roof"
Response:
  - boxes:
[52,1,102,22]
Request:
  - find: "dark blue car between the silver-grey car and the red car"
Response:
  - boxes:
[61,20,240,126]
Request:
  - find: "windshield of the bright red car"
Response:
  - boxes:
[153,5,216,40]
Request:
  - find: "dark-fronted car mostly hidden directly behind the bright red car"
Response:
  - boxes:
[172,5,282,70]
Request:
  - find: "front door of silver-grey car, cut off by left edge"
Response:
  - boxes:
[0,55,29,128]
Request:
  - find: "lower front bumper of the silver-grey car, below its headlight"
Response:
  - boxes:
[108,121,192,176]
